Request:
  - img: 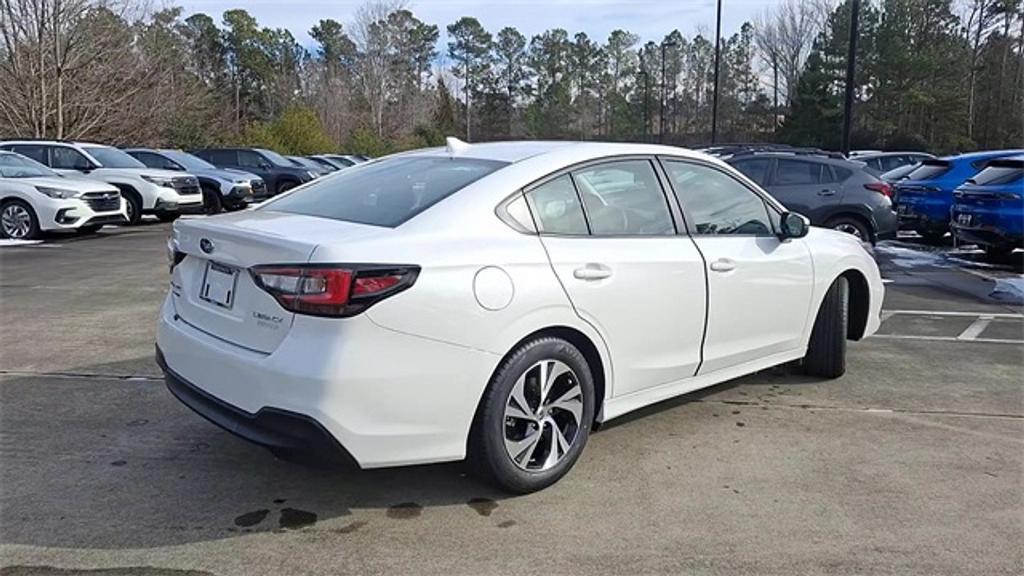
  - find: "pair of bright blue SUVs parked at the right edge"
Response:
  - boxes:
[886,150,1024,257]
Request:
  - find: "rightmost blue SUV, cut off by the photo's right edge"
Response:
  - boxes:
[949,155,1024,260]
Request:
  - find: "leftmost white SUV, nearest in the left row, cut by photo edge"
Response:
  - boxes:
[0,152,128,240]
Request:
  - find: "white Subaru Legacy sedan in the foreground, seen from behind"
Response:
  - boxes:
[157,139,883,492]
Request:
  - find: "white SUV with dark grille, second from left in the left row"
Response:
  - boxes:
[0,140,203,223]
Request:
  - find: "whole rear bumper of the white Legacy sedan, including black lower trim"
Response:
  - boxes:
[157,291,501,468]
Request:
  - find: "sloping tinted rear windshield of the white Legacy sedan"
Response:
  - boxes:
[262,156,507,228]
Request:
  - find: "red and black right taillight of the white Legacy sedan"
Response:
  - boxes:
[252,264,420,318]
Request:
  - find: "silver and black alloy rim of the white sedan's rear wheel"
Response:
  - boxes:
[504,360,584,471]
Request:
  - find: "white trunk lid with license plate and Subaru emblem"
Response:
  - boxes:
[172,210,381,354]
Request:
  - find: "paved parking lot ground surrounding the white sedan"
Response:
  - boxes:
[0,224,1024,576]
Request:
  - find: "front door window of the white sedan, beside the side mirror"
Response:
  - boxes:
[665,160,774,236]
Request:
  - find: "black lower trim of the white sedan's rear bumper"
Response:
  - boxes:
[157,346,358,467]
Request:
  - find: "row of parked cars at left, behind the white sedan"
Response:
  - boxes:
[0,139,368,239]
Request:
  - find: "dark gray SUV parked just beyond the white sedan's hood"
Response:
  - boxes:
[719,150,899,243]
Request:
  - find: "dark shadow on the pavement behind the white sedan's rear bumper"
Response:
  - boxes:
[0,359,508,549]
